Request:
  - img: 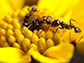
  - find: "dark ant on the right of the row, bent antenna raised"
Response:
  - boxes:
[51,19,81,33]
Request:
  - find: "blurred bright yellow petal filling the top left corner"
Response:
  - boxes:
[0,0,13,18]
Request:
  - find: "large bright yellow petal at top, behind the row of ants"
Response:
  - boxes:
[38,0,79,16]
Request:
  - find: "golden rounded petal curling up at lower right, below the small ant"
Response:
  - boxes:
[43,44,74,62]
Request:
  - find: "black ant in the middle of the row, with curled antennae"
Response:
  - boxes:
[28,16,50,31]
